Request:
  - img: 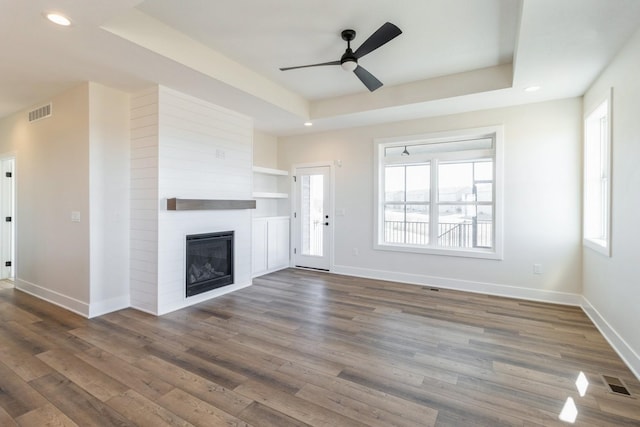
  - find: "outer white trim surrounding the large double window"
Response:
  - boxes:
[373,125,504,260]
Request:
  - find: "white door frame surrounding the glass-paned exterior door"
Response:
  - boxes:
[289,161,336,272]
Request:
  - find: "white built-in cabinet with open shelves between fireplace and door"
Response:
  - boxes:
[251,166,290,277]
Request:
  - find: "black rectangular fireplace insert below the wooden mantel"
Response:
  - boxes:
[186,231,233,297]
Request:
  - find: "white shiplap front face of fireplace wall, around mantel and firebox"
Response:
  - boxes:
[158,87,253,314]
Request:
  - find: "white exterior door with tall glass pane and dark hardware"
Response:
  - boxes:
[293,166,333,270]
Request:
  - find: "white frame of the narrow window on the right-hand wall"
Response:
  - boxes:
[582,88,613,257]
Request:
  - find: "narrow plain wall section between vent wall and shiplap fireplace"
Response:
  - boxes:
[89,83,130,317]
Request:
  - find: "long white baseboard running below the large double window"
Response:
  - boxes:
[332,265,582,306]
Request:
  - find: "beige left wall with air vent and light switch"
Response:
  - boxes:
[0,83,90,315]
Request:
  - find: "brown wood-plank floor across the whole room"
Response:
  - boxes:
[0,270,640,427]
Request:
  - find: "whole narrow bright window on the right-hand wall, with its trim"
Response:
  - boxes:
[583,92,611,255]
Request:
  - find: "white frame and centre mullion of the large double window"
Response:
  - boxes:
[373,125,504,260]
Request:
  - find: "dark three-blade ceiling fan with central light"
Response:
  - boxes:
[280,22,402,92]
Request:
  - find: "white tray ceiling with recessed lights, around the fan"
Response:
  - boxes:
[0,0,640,135]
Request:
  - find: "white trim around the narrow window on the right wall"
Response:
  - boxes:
[582,88,613,257]
